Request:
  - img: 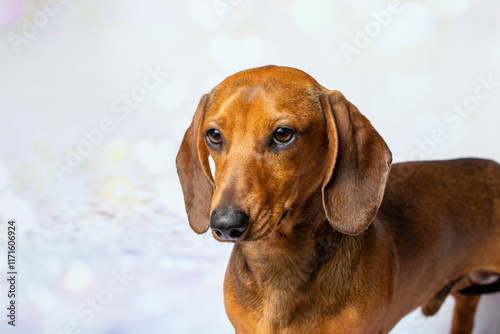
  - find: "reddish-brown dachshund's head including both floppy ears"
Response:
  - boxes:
[177,66,391,241]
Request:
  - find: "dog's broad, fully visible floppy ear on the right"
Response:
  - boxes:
[321,91,392,235]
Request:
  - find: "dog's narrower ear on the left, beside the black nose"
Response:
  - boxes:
[176,95,214,234]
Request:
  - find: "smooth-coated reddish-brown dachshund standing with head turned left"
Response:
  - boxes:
[177,66,500,334]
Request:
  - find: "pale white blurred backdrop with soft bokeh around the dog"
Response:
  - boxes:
[0,0,500,334]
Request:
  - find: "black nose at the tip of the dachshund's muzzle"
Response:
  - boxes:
[210,209,248,241]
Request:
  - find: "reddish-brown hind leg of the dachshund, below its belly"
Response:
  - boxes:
[450,293,480,334]
